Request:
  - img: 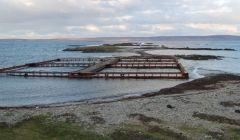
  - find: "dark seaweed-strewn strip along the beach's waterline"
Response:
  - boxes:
[0,74,240,110]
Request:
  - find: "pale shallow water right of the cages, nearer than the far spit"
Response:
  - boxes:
[148,50,240,79]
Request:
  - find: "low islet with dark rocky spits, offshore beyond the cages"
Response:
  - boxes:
[63,43,236,60]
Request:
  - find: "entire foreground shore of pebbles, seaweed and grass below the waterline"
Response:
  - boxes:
[0,74,240,140]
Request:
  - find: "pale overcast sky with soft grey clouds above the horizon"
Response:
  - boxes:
[0,0,240,38]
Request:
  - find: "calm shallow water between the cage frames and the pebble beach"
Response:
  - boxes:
[0,77,186,106]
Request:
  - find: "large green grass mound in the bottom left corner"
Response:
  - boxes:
[0,116,109,140]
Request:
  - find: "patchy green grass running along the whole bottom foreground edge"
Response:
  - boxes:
[0,116,240,140]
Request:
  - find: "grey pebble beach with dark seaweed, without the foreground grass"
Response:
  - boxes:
[0,74,240,139]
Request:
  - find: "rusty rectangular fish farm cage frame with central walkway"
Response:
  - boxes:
[0,56,189,79]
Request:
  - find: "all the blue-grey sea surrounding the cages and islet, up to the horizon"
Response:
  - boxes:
[0,37,240,107]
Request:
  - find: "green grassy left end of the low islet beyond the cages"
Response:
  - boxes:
[64,45,121,53]
